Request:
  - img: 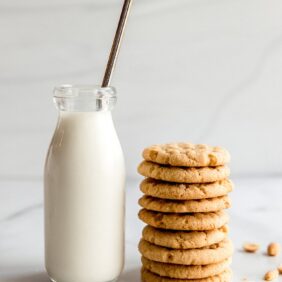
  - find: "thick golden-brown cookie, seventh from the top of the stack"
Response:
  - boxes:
[138,239,233,265]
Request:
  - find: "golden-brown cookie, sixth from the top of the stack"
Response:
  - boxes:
[142,225,228,249]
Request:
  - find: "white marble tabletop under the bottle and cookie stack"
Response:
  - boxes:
[0,178,282,282]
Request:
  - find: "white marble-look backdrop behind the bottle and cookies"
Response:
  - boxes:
[0,0,282,180]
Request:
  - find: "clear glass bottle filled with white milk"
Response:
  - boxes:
[44,85,125,282]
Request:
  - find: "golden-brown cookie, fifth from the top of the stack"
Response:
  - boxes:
[138,209,229,231]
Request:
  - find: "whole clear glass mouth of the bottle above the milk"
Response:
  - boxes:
[54,84,117,112]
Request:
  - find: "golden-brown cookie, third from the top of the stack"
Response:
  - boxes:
[140,178,233,200]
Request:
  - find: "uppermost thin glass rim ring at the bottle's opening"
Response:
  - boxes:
[54,84,116,98]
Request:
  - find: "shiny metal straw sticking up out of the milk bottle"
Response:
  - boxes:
[102,0,132,87]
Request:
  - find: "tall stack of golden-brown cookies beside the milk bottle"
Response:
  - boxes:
[138,143,233,282]
